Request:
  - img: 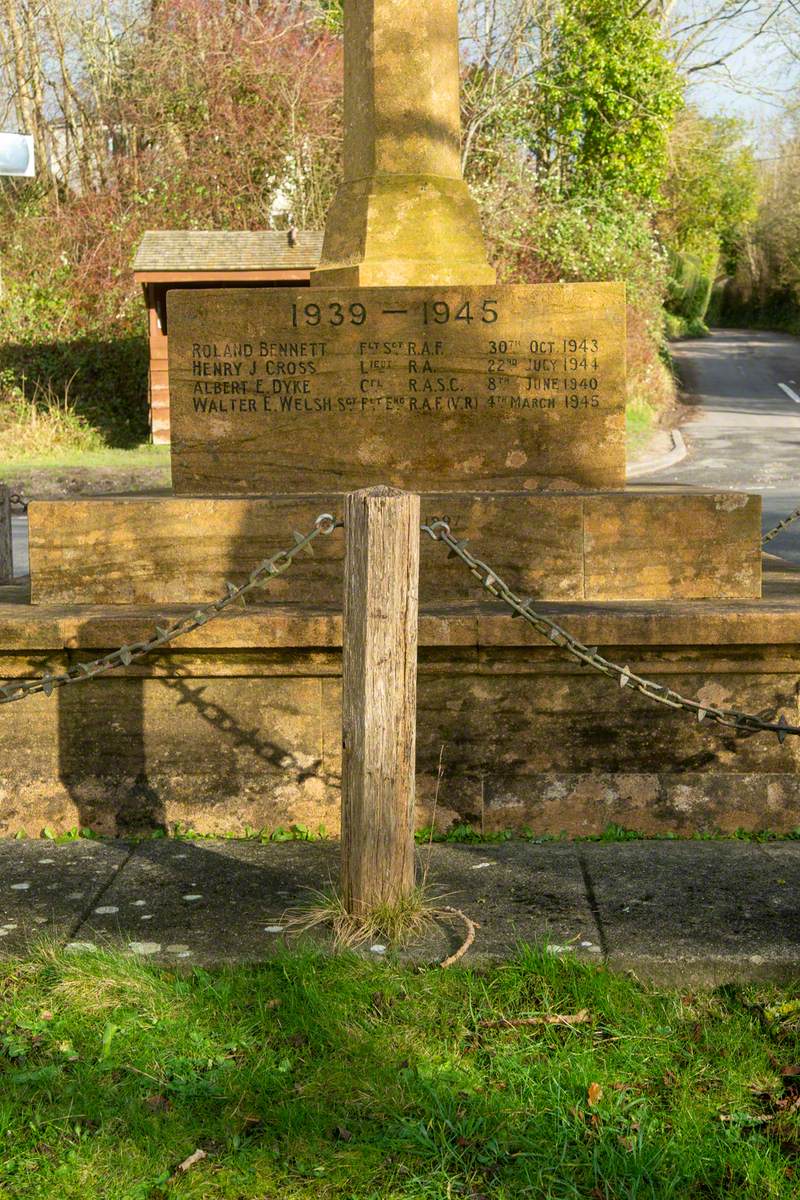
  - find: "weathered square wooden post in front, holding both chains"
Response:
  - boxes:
[342,487,420,916]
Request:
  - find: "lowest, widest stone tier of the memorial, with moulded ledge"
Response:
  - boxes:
[0,559,800,835]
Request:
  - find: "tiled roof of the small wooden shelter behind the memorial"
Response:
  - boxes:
[133,229,323,271]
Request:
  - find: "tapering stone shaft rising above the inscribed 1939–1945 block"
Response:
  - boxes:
[312,0,495,287]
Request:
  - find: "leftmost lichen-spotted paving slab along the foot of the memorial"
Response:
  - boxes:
[0,839,132,958]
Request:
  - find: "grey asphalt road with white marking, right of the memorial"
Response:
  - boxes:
[636,330,800,563]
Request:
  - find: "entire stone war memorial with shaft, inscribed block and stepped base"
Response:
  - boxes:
[0,0,800,864]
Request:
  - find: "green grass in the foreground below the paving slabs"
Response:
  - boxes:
[0,948,800,1200]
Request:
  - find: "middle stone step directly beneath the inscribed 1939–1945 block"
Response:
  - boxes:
[29,492,760,607]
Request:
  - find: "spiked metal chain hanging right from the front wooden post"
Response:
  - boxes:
[422,518,800,744]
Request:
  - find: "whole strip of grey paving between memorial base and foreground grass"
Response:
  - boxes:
[0,839,800,986]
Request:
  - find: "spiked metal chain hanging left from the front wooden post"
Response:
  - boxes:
[0,512,341,704]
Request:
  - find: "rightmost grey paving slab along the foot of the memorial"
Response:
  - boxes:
[581,841,800,986]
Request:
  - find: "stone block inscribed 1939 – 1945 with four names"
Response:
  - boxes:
[168,283,625,496]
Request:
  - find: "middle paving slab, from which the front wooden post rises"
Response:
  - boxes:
[74,840,600,965]
